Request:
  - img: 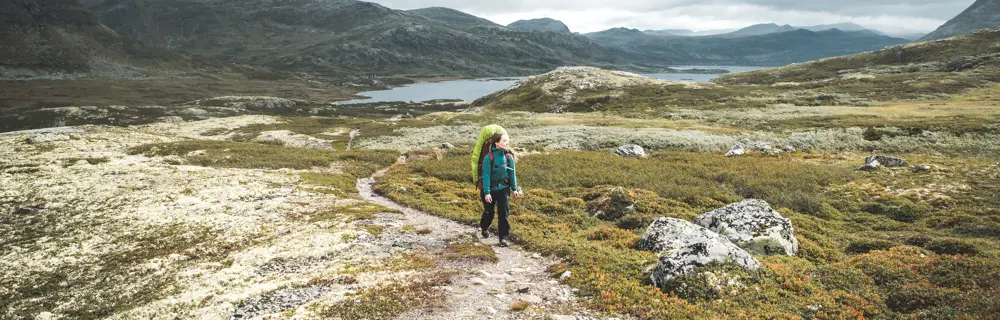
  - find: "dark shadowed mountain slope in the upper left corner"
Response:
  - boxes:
[0,0,211,79]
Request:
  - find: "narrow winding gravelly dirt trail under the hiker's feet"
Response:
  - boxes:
[357,158,608,320]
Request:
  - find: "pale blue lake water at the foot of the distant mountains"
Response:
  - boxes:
[340,66,763,104]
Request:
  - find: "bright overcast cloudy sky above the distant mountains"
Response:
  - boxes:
[370,0,975,34]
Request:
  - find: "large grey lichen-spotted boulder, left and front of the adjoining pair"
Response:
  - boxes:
[638,218,760,288]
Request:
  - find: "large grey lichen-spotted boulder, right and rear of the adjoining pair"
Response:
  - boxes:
[694,199,799,256]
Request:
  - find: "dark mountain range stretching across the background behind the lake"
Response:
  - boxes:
[0,0,998,79]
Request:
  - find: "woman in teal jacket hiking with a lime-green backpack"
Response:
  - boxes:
[477,132,521,247]
